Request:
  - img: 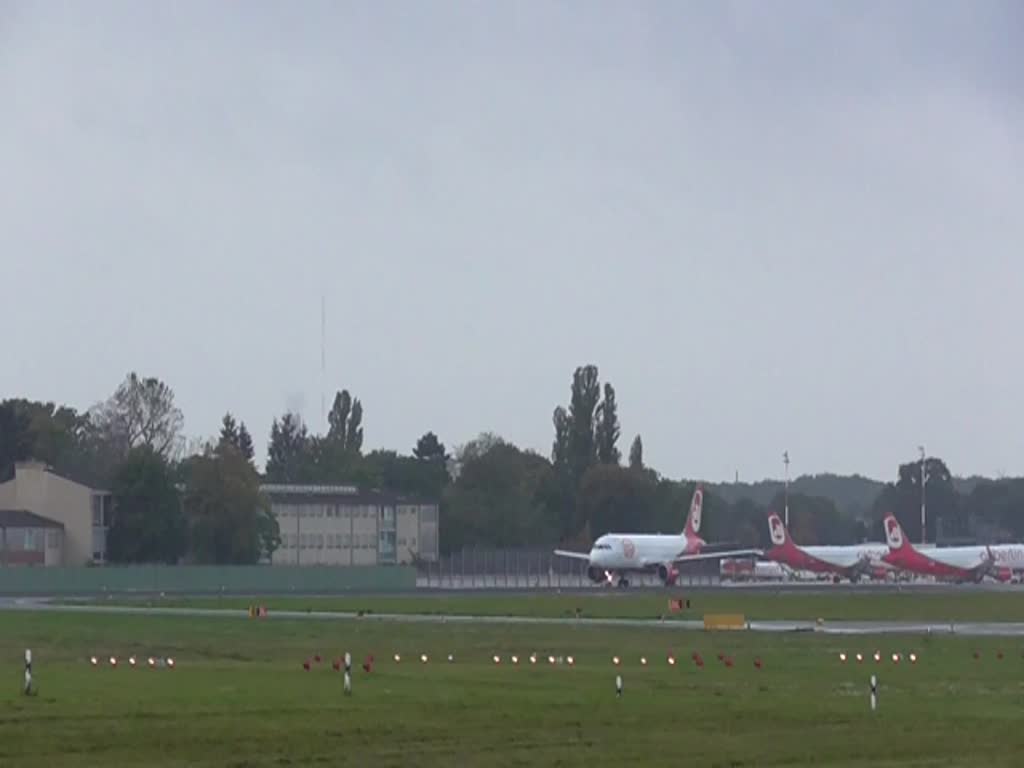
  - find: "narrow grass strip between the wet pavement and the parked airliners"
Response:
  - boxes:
[81,589,1024,622]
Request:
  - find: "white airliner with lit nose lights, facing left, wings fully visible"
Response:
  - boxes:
[555,485,762,587]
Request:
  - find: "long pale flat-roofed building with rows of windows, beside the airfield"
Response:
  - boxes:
[261,483,438,565]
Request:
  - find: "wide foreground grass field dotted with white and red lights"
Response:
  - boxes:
[6,600,1024,768]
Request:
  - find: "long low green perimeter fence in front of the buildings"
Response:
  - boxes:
[0,565,416,596]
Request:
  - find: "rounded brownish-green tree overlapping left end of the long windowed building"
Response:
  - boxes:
[184,443,281,564]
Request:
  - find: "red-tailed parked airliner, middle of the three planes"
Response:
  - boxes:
[765,512,893,582]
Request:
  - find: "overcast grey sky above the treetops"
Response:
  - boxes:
[0,0,1024,480]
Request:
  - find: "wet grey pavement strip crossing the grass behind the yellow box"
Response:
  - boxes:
[6,598,1024,637]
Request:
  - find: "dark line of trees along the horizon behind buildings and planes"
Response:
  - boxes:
[0,365,1024,563]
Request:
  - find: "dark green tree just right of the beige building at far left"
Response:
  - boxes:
[106,445,185,564]
